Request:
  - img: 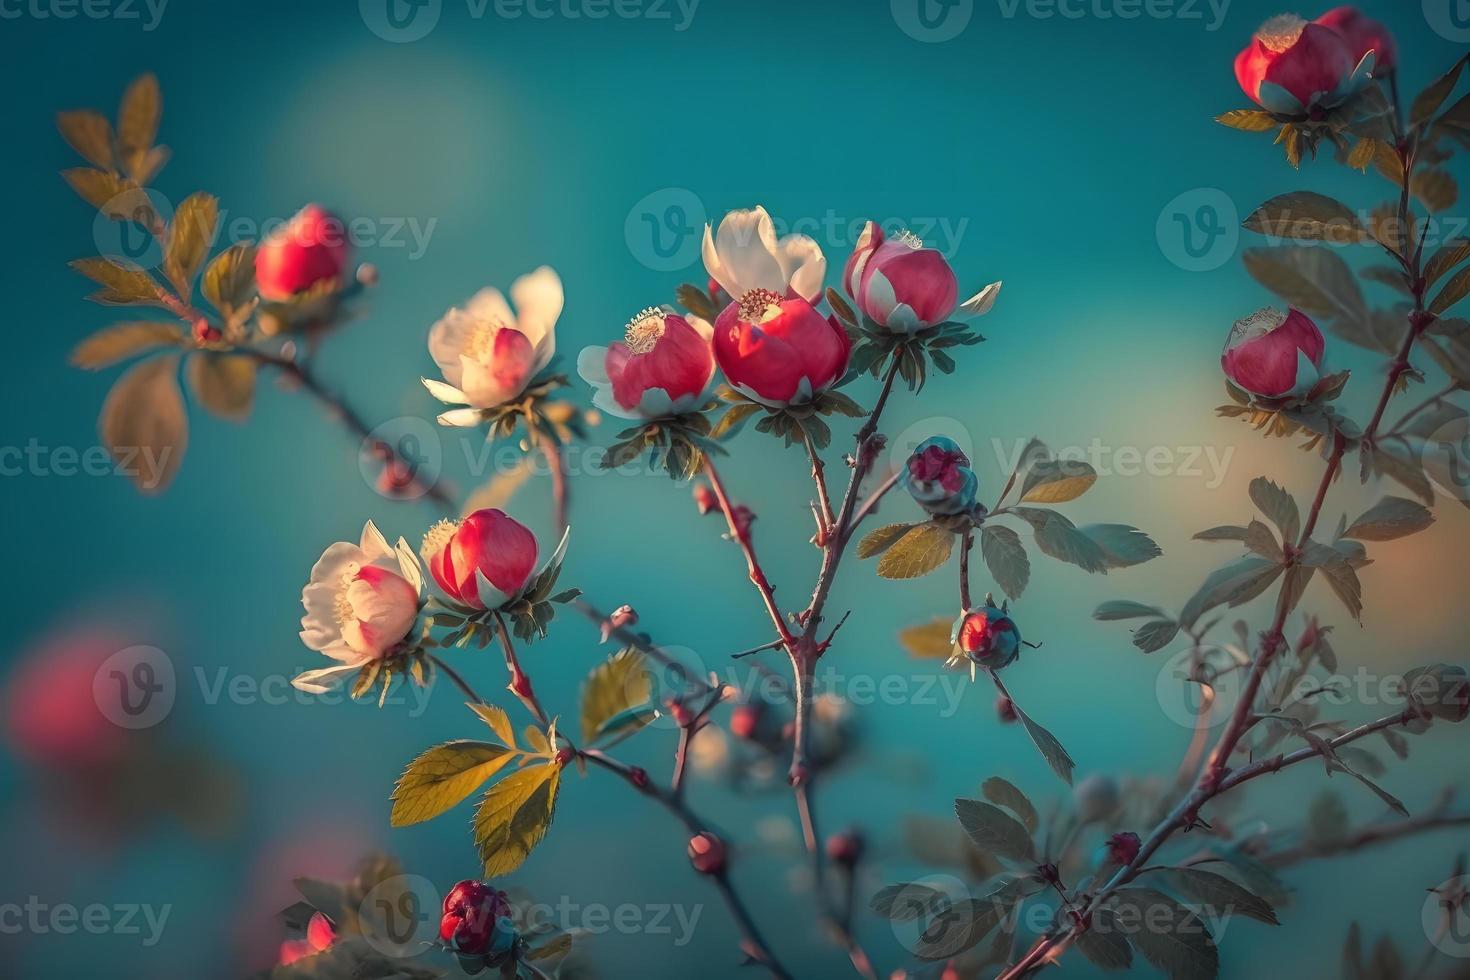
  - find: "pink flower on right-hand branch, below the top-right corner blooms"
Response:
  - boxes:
[1220,307,1326,398]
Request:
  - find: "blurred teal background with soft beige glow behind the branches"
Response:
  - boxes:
[0,0,1470,979]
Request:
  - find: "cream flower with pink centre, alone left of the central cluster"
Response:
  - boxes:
[423,266,563,425]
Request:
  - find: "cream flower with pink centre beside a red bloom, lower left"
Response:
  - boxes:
[291,520,423,693]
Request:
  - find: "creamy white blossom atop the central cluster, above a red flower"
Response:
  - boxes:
[704,207,826,304]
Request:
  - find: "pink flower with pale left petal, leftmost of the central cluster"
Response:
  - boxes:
[576,307,714,419]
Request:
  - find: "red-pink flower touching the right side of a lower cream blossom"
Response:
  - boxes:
[423,508,546,608]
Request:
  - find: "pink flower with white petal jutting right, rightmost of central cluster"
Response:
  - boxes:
[842,222,1001,334]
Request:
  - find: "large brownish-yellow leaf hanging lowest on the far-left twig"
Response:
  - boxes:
[98,354,188,494]
